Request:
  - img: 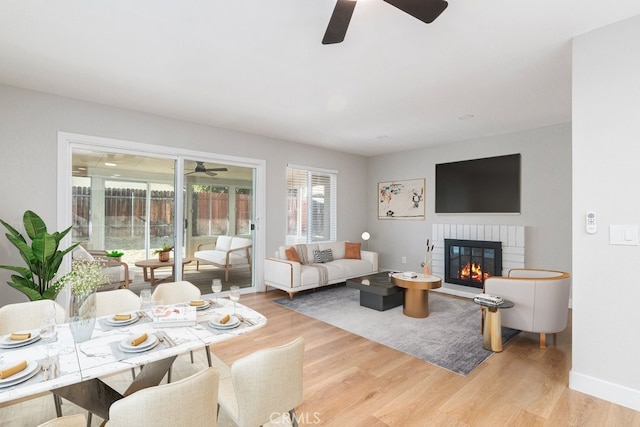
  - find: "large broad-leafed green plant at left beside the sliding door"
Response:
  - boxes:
[0,211,80,301]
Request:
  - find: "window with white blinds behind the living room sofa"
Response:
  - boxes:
[286,165,338,245]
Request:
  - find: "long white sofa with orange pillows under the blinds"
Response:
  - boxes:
[264,241,378,299]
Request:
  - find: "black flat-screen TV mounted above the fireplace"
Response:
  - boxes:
[436,154,520,213]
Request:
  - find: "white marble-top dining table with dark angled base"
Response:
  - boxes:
[0,298,267,419]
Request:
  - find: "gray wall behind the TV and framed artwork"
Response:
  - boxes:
[367,124,571,271]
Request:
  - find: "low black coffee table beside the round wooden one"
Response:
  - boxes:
[347,272,404,311]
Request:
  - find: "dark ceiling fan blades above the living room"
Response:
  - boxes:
[322,0,449,44]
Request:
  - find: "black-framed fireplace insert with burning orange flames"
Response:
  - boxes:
[444,239,502,289]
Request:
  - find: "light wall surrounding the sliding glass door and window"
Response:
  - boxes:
[0,85,367,305]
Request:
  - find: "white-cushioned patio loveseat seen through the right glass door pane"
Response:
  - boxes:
[193,236,253,282]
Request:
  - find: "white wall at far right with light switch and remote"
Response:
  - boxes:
[569,17,640,410]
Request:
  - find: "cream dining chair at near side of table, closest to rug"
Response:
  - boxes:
[218,337,304,427]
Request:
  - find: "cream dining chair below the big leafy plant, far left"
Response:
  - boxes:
[0,299,67,335]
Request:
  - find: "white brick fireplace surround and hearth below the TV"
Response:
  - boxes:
[431,224,525,297]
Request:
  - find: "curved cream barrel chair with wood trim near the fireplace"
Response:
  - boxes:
[484,268,571,348]
